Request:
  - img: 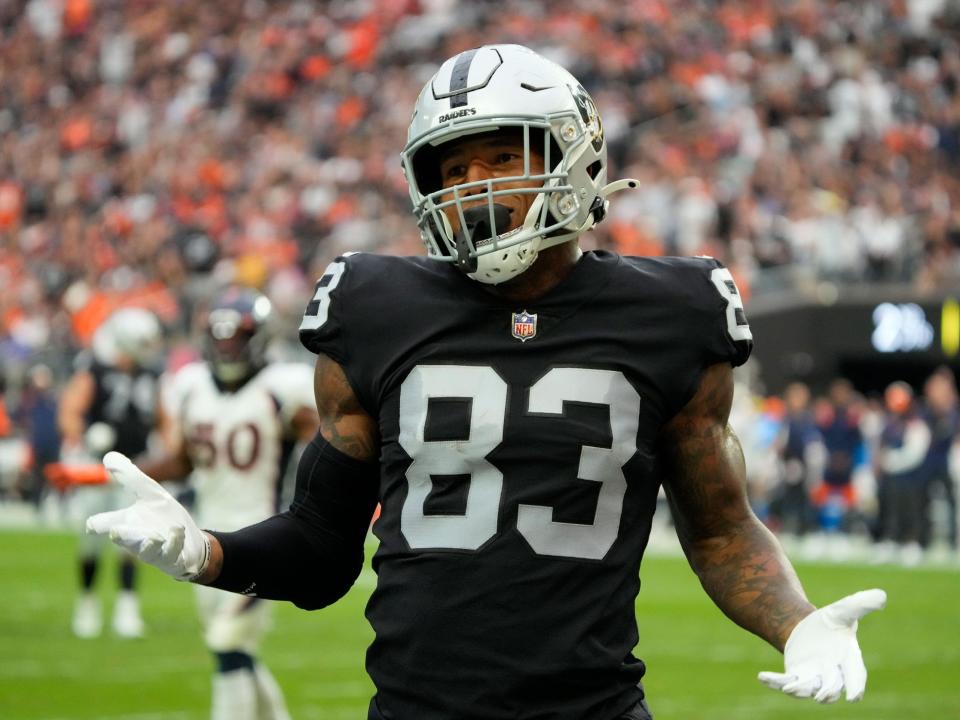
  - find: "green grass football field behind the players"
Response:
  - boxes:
[0,531,960,720]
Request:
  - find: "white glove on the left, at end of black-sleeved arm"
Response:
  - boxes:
[87,452,210,580]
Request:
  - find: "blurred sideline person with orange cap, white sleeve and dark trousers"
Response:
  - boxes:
[876,381,930,566]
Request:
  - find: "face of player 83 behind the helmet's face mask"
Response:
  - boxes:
[440,135,543,233]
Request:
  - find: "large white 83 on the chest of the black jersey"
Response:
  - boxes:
[399,365,640,560]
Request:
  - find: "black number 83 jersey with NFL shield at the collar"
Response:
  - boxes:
[300,252,752,720]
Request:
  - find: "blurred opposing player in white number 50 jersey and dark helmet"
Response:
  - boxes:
[142,288,317,720]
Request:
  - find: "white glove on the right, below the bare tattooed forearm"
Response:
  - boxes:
[758,589,887,703]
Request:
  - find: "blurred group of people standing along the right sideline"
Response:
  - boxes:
[731,366,960,566]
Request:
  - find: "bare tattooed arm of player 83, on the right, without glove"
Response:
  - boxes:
[660,363,815,651]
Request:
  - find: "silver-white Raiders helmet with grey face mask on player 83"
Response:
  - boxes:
[401,45,639,284]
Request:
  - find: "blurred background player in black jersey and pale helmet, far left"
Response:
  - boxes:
[58,308,162,637]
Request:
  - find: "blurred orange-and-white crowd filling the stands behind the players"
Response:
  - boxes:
[0,0,960,560]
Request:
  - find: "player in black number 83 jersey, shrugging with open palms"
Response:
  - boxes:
[88,45,885,720]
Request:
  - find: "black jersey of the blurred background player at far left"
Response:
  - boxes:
[77,355,158,457]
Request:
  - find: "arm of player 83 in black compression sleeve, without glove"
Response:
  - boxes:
[198,355,380,609]
